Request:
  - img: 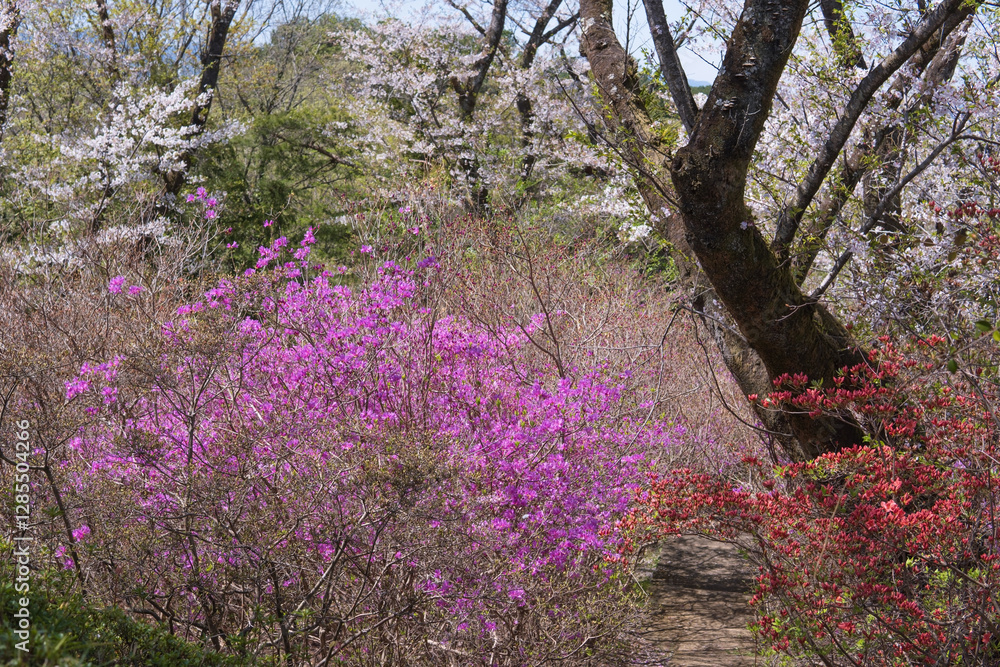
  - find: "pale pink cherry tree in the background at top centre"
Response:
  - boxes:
[348,2,584,212]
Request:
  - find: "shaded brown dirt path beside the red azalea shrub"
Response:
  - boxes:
[644,536,766,667]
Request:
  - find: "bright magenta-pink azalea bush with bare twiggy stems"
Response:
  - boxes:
[61,237,681,665]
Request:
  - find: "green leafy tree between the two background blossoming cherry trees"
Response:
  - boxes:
[194,15,367,268]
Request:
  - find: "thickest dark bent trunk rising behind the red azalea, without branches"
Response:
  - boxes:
[670,0,865,456]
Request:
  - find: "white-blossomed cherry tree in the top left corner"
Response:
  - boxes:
[3,0,249,244]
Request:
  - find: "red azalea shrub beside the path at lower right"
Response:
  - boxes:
[622,336,1000,665]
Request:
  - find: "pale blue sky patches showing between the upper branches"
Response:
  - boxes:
[344,0,721,85]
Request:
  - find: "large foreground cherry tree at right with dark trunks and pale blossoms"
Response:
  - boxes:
[581,0,996,458]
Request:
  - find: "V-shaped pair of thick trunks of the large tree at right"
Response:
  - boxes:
[581,0,864,460]
